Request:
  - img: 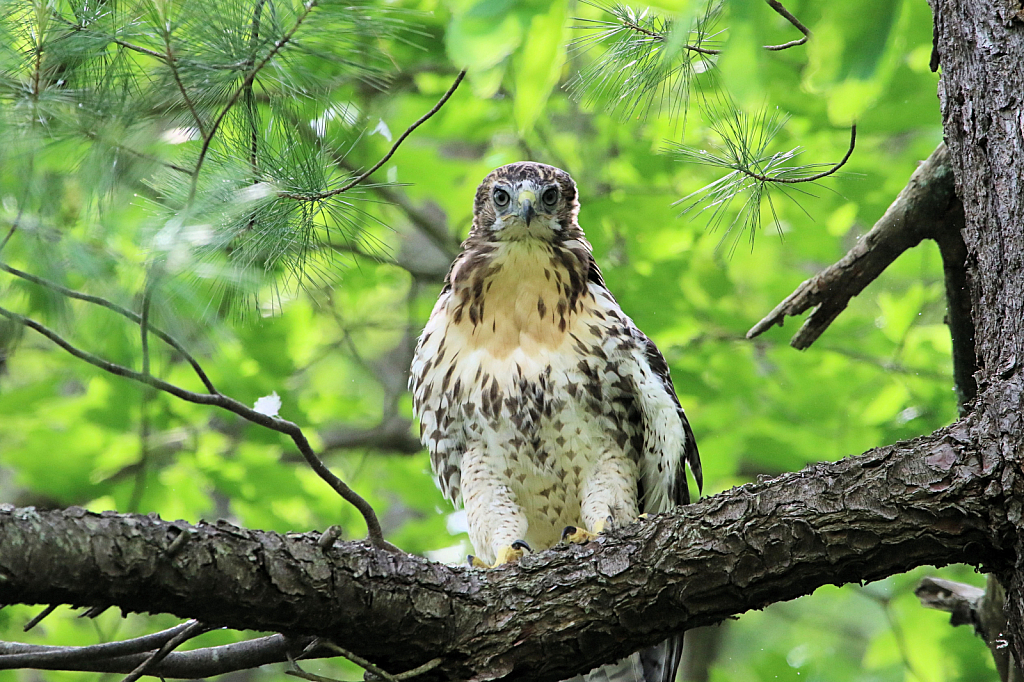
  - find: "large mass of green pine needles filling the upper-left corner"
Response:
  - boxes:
[0,0,407,313]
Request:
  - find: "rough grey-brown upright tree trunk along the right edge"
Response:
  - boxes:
[931,0,1024,660]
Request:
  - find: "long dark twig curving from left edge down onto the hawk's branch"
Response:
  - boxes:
[0,307,389,552]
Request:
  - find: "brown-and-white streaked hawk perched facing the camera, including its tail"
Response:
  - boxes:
[410,162,702,682]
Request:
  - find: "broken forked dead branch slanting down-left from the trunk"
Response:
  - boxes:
[746,144,973,348]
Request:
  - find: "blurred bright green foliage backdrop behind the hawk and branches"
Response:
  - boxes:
[0,0,995,682]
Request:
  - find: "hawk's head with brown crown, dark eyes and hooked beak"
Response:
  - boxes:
[470,161,582,242]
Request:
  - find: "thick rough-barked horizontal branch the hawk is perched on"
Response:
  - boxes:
[0,422,1012,681]
